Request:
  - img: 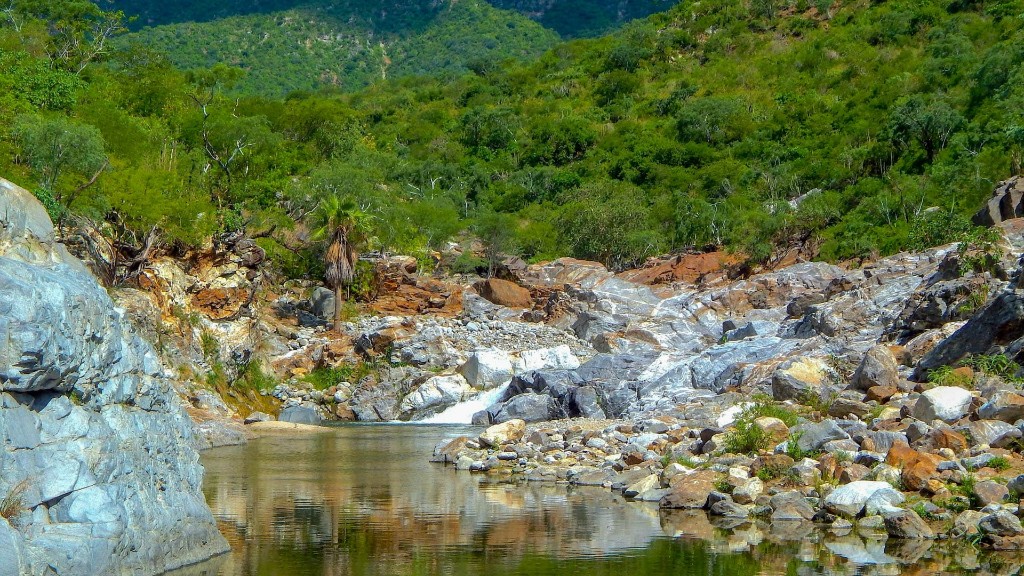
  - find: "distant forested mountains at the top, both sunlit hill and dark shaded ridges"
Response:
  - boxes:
[111,0,674,96]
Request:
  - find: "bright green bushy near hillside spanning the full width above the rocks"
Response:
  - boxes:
[0,0,1024,279]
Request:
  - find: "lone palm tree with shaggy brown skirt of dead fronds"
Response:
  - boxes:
[313,196,367,330]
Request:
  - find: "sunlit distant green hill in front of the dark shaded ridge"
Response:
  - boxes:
[120,1,558,95]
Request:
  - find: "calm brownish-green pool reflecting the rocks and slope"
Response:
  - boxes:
[174,425,1011,576]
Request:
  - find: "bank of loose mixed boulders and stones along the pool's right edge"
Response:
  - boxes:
[431,388,1024,550]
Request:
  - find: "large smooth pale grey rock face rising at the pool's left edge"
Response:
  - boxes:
[0,179,227,574]
